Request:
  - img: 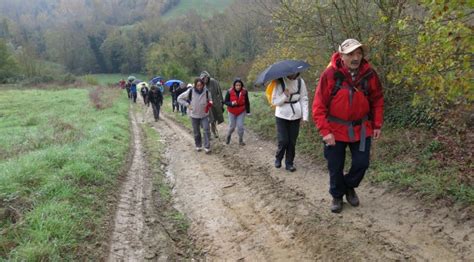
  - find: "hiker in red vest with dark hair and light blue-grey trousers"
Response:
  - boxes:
[224,78,250,146]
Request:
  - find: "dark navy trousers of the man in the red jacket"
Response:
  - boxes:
[324,137,371,198]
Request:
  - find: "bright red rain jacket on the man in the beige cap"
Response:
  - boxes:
[312,53,384,142]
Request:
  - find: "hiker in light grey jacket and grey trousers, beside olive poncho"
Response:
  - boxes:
[178,78,213,154]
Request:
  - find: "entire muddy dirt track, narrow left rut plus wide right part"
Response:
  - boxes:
[110,102,474,261]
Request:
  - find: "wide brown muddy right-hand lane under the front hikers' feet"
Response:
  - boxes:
[157,108,473,261]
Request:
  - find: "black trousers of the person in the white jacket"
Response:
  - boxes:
[275,117,300,166]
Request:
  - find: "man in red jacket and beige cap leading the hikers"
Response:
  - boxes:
[313,39,384,213]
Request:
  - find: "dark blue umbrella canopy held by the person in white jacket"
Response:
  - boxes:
[255,60,309,85]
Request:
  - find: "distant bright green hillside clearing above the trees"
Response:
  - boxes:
[162,0,234,19]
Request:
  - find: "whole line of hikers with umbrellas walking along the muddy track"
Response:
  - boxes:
[121,39,384,213]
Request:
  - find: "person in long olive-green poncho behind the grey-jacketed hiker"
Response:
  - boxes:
[200,71,224,138]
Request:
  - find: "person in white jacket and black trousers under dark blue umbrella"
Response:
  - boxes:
[272,73,308,172]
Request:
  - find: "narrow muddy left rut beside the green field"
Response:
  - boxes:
[107,105,174,261]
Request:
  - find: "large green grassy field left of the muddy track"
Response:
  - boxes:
[0,89,130,261]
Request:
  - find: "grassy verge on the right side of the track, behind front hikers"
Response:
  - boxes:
[245,92,474,204]
